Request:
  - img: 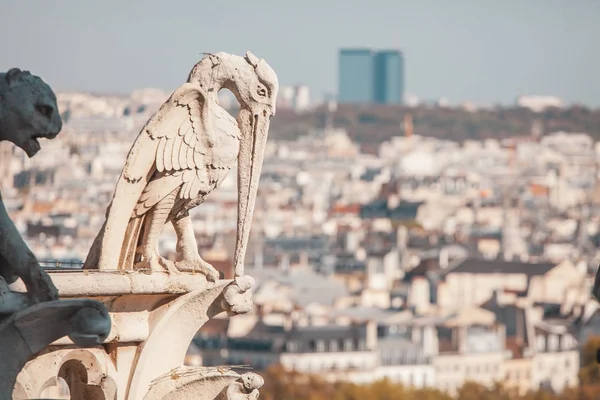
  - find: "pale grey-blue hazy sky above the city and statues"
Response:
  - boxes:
[0,0,600,107]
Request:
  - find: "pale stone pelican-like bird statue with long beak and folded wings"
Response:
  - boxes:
[84,52,278,281]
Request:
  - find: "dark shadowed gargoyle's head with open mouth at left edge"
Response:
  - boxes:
[0,68,62,157]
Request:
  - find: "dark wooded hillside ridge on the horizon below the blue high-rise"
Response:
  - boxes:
[272,105,600,151]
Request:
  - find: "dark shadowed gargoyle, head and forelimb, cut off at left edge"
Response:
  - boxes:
[0,68,62,313]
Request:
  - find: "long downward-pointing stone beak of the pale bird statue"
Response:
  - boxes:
[233,105,271,277]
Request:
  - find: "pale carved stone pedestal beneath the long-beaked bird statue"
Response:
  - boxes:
[13,270,262,400]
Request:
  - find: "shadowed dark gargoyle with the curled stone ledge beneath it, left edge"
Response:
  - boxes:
[0,68,111,399]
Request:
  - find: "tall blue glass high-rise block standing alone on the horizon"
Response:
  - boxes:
[338,49,404,104]
